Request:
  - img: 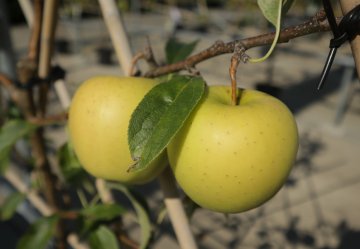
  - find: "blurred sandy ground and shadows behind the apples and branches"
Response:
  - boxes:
[0,0,360,249]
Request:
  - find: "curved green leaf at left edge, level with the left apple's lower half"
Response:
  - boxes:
[0,119,37,173]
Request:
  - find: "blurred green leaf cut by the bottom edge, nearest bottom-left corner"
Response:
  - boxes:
[16,215,59,249]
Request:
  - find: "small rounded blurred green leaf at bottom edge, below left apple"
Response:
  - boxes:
[89,226,120,249]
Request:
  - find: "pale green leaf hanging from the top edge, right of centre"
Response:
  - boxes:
[257,0,294,27]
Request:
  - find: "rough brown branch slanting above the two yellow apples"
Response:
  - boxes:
[145,10,330,78]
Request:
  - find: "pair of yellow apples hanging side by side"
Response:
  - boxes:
[69,76,298,213]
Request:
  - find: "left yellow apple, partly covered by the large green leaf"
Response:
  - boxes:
[68,76,167,184]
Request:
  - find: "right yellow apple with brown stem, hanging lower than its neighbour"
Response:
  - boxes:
[167,86,298,213]
